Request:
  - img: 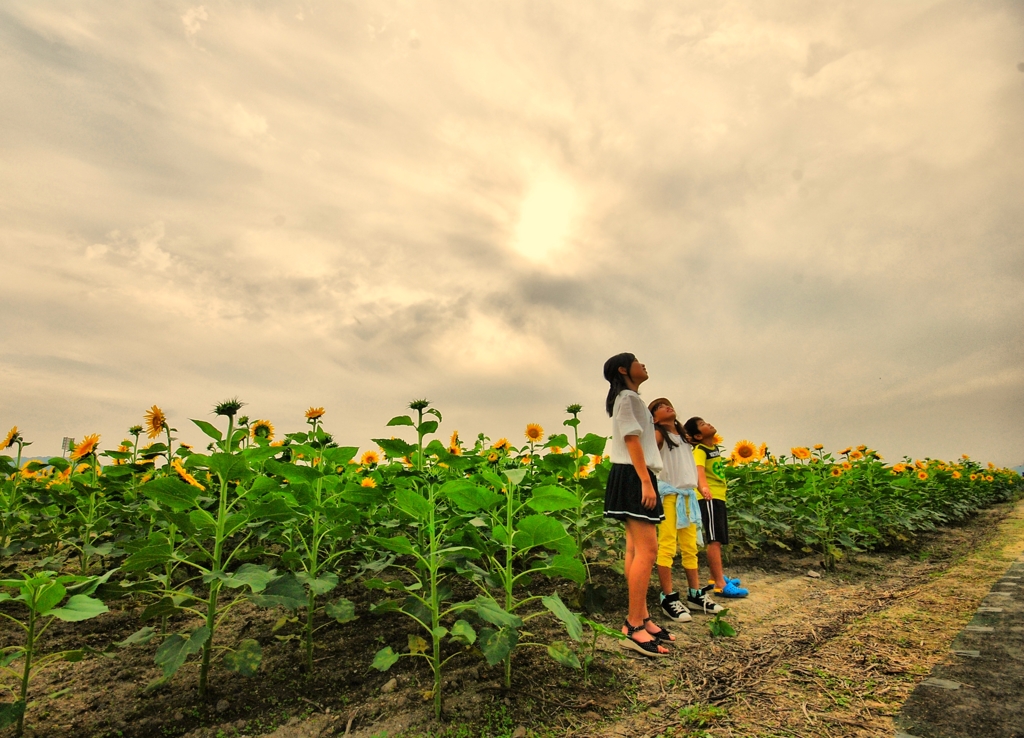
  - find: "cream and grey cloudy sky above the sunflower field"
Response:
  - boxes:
[0,0,1024,466]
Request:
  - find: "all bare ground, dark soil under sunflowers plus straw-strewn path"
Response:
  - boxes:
[0,503,1024,738]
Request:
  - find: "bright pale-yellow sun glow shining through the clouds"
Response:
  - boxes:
[512,172,580,266]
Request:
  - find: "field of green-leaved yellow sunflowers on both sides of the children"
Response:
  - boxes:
[0,399,1021,735]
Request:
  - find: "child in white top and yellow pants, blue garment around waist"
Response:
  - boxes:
[647,397,725,622]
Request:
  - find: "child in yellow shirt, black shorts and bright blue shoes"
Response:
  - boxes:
[683,418,749,598]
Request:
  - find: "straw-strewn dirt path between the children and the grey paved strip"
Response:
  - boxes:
[567,503,1024,738]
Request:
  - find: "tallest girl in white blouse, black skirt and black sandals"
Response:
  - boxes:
[604,353,675,656]
